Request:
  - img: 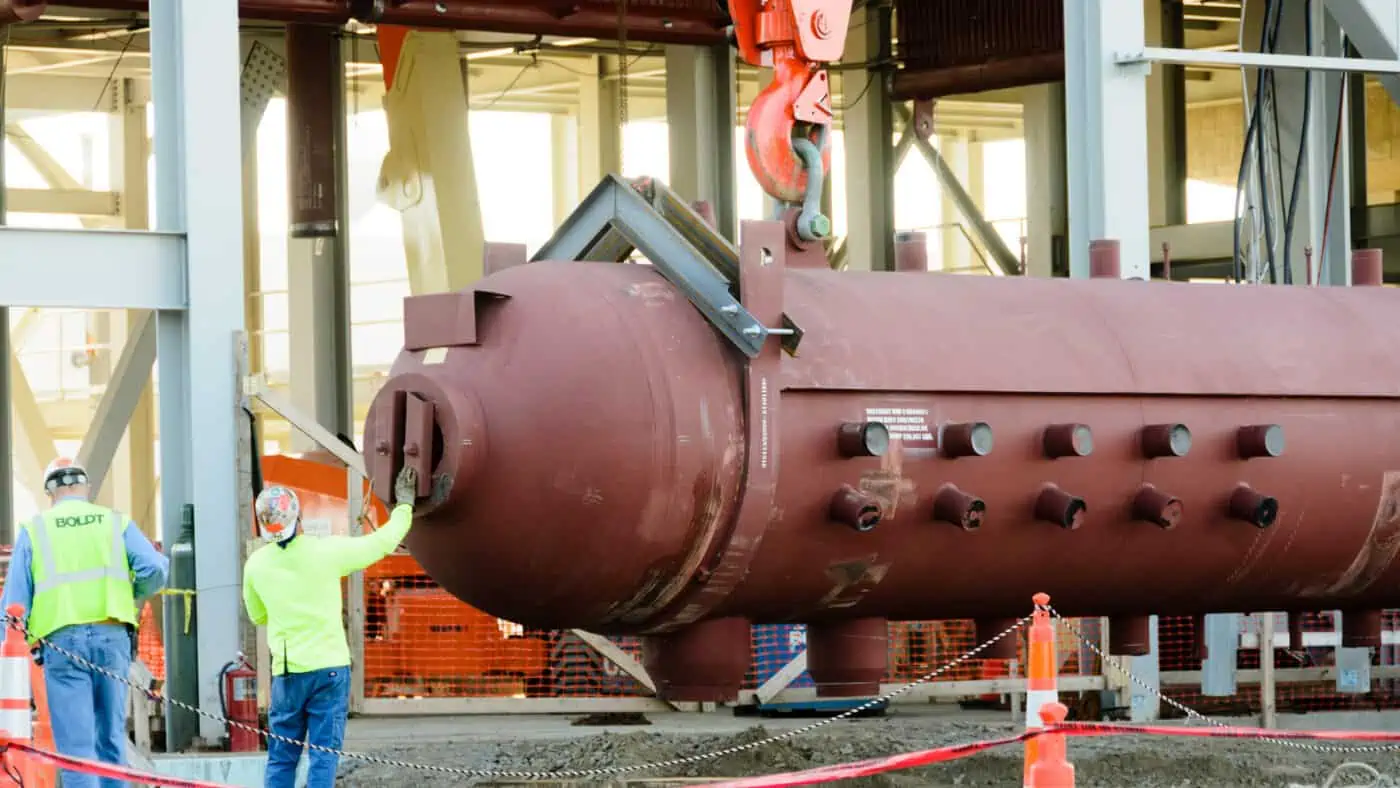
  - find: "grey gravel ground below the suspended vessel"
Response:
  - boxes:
[330,715,1400,788]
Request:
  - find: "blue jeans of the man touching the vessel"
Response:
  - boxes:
[263,665,350,788]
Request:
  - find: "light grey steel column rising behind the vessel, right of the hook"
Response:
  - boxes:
[1064,0,1151,279]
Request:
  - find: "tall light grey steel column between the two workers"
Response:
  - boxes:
[150,0,244,742]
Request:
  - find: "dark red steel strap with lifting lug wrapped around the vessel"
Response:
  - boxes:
[652,221,787,633]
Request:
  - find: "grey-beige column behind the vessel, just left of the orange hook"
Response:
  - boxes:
[666,45,739,241]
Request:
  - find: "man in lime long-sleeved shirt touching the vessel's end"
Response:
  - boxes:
[244,467,417,788]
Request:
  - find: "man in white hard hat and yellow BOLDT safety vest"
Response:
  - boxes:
[0,458,169,788]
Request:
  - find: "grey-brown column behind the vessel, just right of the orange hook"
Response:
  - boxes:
[841,3,895,270]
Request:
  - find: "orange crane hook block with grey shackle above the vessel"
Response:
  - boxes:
[729,0,851,239]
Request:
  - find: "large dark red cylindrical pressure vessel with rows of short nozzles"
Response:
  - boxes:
[365,263,1400,633]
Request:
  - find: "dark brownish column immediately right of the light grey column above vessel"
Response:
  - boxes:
[1142,0,1186,227]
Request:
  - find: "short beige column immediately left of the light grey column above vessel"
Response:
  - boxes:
[1023,83,1070,276]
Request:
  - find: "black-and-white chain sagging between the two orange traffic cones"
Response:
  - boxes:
[3,616,1030,780]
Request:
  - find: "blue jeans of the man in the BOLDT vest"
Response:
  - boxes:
[42,624,132,788]
